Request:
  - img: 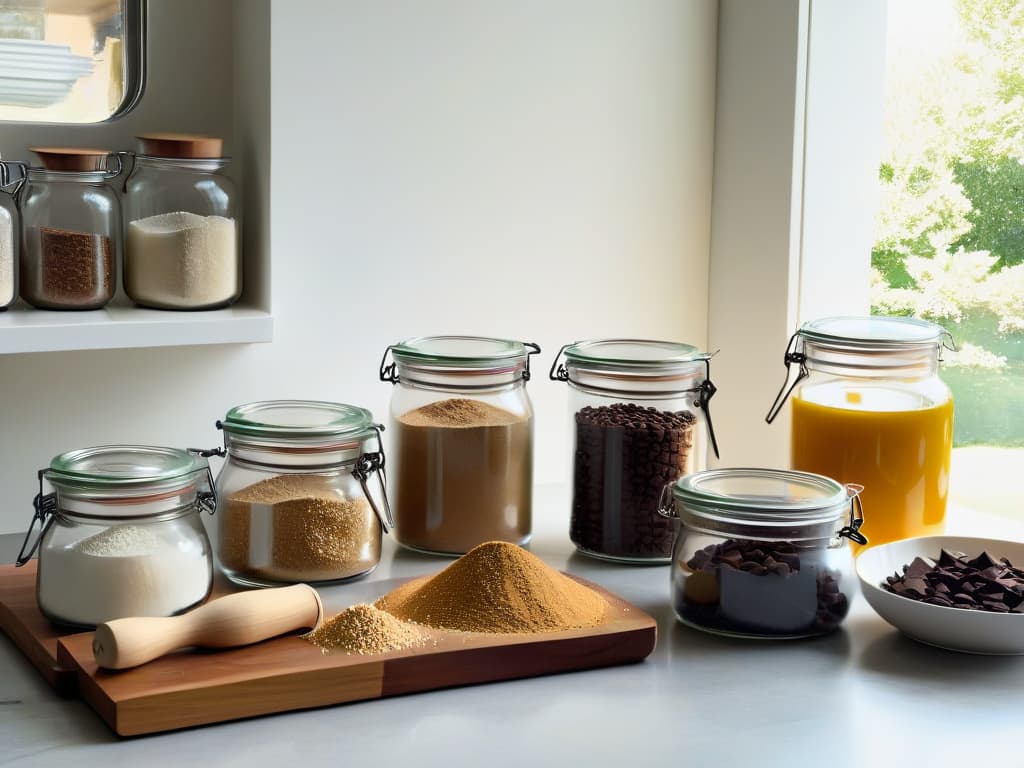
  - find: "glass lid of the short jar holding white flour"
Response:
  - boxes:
[46,445,209,490]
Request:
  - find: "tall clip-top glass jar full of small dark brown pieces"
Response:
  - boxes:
[550,339,718,563]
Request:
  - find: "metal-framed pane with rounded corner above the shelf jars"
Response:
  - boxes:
[0,0,145,123]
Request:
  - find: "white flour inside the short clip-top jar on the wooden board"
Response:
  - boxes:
[39,523,212,625]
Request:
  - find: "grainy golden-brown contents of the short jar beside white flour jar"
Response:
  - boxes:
[218,474,381,582]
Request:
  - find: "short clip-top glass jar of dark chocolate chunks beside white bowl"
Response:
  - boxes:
[660,469,865,639]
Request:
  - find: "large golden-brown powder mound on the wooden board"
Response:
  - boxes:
[375,542,607,633]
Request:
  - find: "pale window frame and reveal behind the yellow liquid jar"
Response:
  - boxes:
[708,0,886,467]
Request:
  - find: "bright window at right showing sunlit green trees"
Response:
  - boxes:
[871,0,1024,516]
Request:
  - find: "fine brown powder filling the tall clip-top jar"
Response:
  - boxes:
[394,398,532,554]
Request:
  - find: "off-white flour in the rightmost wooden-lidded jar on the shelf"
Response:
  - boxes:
[125,211,239,309]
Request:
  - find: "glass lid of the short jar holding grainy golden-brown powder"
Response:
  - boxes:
[218,400,374,441]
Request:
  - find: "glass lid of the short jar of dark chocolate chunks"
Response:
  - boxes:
[673,468,849,523]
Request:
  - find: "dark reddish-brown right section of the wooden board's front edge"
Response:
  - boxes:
[383,623,657,696]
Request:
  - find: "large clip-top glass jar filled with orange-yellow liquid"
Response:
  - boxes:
[767,316,953,544]
